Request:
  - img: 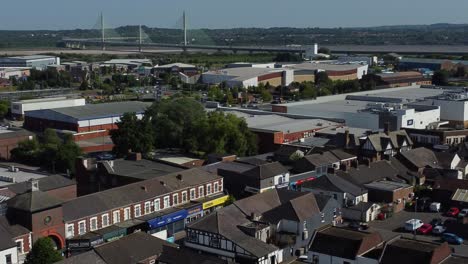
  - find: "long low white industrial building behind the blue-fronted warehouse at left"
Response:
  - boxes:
[11,97,86,118]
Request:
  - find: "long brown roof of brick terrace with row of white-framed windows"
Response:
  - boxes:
[63,168,221,221]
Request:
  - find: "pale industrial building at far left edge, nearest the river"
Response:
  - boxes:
[0,55,60,70]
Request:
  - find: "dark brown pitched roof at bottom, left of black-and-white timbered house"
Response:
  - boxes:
[94,232,177,264]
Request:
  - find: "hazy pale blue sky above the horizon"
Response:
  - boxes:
[0,0,468,29]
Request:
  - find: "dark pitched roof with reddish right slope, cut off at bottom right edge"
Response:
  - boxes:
[381,239,452,264]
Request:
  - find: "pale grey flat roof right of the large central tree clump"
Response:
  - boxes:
[228,111,340,133]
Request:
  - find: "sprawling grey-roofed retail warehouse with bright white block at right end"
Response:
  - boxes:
[272,86,443,130]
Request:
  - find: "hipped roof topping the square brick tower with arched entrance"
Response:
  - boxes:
[7,191,63,212]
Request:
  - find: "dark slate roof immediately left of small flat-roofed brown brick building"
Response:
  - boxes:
[302,174,367,196]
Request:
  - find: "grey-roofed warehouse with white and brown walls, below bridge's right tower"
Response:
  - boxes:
[201,67,294,88]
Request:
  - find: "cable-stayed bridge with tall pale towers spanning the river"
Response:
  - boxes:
[61,12,311,55]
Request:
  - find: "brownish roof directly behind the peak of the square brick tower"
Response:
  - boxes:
[7,175,76,194]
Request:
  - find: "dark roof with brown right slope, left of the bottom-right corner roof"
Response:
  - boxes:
[309,227,382,263]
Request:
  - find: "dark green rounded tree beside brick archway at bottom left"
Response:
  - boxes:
[24,237,63,264]
